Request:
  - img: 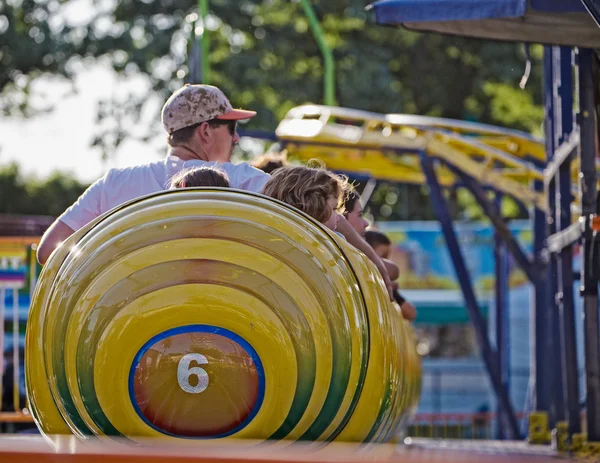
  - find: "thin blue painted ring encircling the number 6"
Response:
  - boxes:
[129,325,265,439]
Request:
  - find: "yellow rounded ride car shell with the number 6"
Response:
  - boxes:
[26,189,421,442]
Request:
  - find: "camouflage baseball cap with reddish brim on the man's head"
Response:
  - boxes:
[161,84,256,134]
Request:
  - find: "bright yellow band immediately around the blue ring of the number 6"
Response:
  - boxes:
[94,284,297,438]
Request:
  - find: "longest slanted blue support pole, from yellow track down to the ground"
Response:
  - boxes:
[421,152,520,439]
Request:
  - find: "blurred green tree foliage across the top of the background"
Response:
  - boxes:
[0,0,543,158]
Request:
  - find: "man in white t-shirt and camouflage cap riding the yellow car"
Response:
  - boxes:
[37,85,269,264]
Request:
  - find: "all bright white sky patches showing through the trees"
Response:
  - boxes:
[0,0,253,183]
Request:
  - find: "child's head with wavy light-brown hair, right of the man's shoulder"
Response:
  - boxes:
[262,166,348,230]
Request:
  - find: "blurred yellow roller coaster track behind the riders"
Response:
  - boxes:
[276,105,592,212]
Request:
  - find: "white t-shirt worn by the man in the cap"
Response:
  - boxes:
[59,156,269,230]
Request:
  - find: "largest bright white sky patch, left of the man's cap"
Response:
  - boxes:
[0,65,166,182]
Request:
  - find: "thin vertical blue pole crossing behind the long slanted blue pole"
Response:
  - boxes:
[494,193,510,440]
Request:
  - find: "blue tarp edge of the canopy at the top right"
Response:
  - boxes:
[371,0,585,25]
